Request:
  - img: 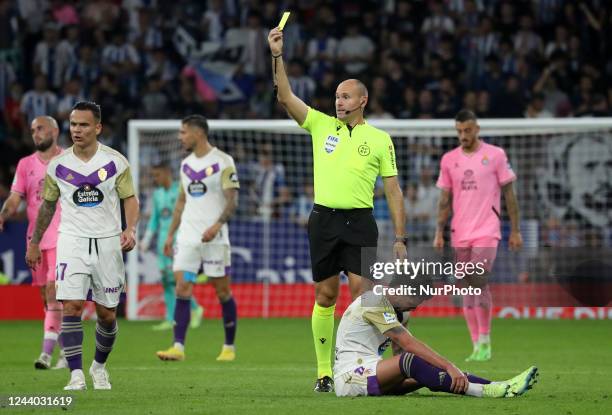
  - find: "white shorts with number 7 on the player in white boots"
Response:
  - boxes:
[55,233,125,308]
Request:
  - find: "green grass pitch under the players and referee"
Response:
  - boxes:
[0,318,612,415]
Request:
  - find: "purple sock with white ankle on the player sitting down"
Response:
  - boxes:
[399,353,491,396]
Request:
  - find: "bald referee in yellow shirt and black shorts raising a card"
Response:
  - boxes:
[268,28,406,392]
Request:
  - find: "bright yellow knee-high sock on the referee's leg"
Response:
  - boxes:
[312,303,336,379]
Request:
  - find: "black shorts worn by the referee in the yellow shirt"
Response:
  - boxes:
[308,204,378,282]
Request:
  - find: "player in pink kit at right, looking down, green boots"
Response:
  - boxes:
[433,110,523,361]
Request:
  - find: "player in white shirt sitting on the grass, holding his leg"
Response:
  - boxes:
[334,291,538,398]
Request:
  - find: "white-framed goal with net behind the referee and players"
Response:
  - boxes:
[128,118,612,319]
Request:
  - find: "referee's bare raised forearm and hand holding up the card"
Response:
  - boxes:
[268,27,308,125]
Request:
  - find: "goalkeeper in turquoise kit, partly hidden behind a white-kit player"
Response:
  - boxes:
[140,163,204,330]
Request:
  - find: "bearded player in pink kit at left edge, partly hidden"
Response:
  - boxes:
[0,116,67,369]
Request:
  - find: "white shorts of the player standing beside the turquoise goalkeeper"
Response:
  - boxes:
[172,241,232,278]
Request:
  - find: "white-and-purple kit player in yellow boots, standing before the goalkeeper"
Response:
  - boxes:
[157,115,240,361]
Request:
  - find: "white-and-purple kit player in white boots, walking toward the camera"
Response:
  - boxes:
[26,101,138,390]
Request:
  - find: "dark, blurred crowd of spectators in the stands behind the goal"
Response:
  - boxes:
[0,0,612,224]
